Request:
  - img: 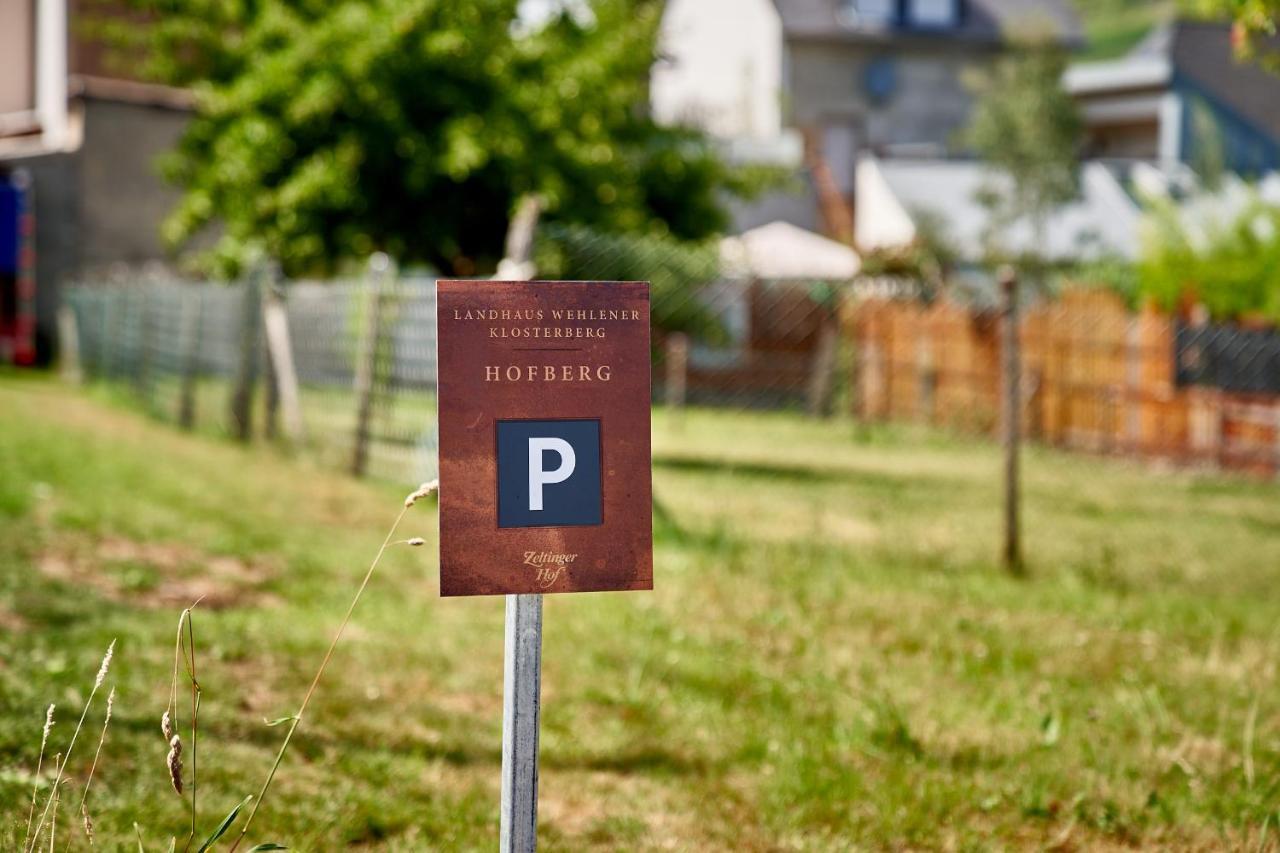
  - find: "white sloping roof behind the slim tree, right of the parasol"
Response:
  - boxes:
[858,159,1139,261]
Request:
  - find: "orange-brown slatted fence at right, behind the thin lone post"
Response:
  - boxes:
[844,291,1280,475]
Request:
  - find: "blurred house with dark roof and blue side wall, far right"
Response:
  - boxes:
[1064,20,1280,174]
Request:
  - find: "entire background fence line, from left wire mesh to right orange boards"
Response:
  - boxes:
[60,233,1280,482]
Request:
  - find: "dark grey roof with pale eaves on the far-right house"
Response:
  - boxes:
[1064,20,1280,140]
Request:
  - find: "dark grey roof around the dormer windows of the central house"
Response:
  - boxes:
[773,0,1084,44]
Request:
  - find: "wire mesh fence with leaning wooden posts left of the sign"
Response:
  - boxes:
[68,267,436,482]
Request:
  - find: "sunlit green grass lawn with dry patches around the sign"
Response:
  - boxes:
[0,374,1280,850]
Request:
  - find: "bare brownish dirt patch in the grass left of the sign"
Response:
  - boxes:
[37,537,278,610]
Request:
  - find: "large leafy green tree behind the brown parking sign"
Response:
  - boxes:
[90,0,754,274]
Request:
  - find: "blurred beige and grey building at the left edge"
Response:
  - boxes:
[0,0,191,362]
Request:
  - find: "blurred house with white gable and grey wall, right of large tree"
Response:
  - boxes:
[652,0,1082,241]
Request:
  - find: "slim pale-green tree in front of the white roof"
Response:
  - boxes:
[961,38,1080,275]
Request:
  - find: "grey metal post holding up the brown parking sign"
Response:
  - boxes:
[500,594,543,853]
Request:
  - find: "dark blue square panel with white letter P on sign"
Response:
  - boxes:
[498,420,604,528]
